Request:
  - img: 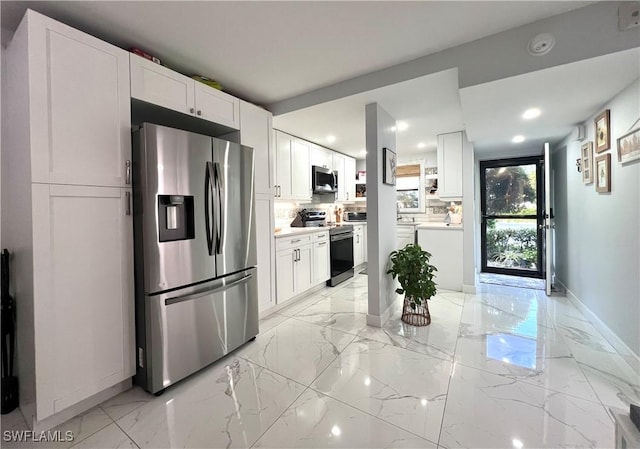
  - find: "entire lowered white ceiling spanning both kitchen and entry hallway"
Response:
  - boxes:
[273,48,640,159]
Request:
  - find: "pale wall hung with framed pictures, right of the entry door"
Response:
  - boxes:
[552,80,640,355]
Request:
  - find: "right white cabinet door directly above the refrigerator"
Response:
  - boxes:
[193,81,240,129]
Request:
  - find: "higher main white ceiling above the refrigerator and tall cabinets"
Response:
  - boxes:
[0,1,591,104]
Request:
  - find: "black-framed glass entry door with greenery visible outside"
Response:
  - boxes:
[480,157,544,278]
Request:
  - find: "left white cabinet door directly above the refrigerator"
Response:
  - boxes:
[130,53,195,115]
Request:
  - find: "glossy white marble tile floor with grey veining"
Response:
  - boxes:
[2,275,640,449]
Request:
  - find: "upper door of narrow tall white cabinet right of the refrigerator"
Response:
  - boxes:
[240,101,273,195]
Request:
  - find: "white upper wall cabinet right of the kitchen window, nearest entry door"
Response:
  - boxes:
[438,131,462,199]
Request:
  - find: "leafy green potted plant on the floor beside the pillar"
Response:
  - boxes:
[387,243,438,326]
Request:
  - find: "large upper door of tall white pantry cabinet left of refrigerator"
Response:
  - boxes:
[25,11,131,187]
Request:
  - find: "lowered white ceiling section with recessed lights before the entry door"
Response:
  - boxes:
[460,48,640,154]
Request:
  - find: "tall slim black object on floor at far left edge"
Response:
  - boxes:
[0,249,19,415]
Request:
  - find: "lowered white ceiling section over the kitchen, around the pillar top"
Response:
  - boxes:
[273,65,464,159]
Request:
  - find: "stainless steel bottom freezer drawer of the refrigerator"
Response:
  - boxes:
[146,268,258,393]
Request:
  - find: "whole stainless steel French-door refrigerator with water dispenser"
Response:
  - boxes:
[133,123,258,393]
